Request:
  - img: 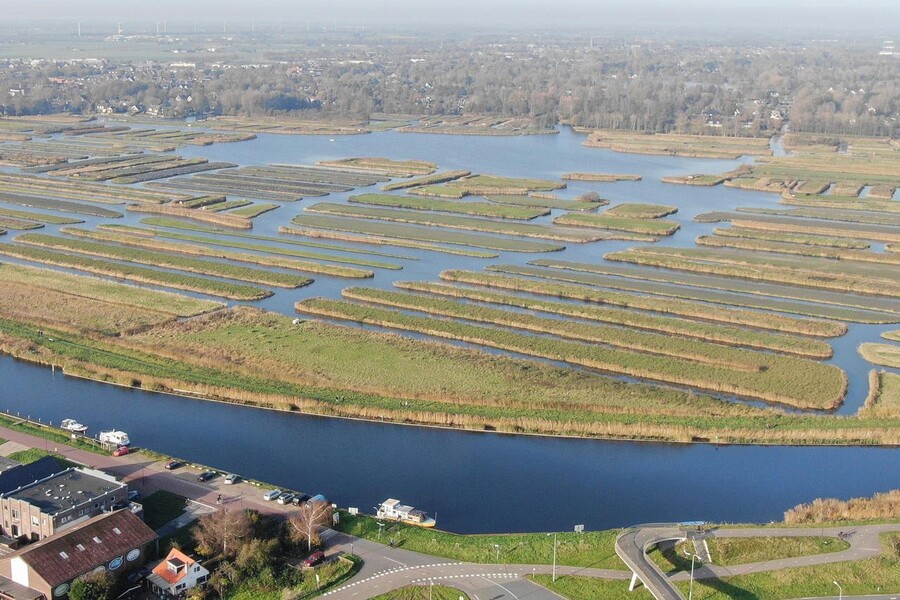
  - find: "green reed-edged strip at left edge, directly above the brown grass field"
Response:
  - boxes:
[0,244,272,300]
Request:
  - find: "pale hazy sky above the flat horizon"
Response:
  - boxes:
[0,0,900,34]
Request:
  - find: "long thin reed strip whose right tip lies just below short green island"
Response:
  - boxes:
[306,202,614,244]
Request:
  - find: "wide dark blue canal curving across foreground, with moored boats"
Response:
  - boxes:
[0,357,900,532]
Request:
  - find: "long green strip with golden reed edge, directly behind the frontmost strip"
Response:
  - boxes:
[342,288,778,371]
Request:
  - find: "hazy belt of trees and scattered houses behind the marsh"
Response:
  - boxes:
[0,39,900,135]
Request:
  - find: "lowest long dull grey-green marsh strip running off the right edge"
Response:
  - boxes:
[528,259,900,323]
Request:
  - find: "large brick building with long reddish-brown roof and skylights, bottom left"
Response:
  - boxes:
[0,509,157,600]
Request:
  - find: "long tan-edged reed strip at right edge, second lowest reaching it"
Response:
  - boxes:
[604,248,900,297]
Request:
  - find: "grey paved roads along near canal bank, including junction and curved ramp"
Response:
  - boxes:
[0,427,900,600]
